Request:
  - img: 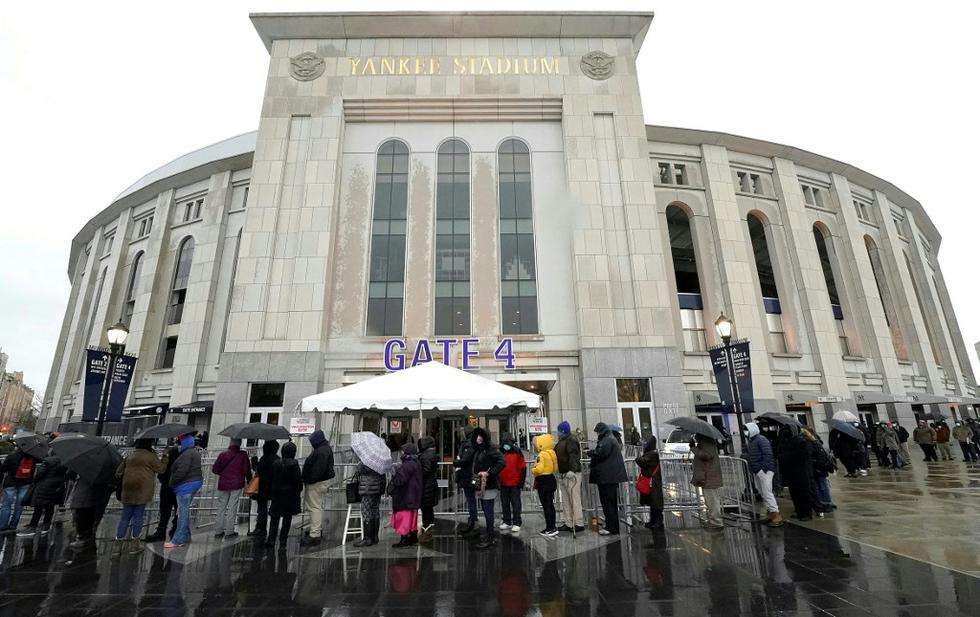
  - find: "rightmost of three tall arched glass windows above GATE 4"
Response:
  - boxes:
[497,139,538,334]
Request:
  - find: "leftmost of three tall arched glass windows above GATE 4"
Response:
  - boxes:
[367,139,408,336]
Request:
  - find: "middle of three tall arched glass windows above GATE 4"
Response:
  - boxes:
[434,139,470,334]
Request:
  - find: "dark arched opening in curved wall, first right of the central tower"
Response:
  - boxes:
[666,206,706,351]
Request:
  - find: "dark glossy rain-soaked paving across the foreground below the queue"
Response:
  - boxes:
[0,482,980,617]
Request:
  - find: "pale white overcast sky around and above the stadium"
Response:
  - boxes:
[0,0,980,390]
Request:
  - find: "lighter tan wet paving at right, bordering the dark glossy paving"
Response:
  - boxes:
[783,460,980,576]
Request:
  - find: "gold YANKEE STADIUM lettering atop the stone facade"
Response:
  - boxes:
[347,56,561,75]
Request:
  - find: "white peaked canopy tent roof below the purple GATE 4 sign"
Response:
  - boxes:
[300,362,541,416]
